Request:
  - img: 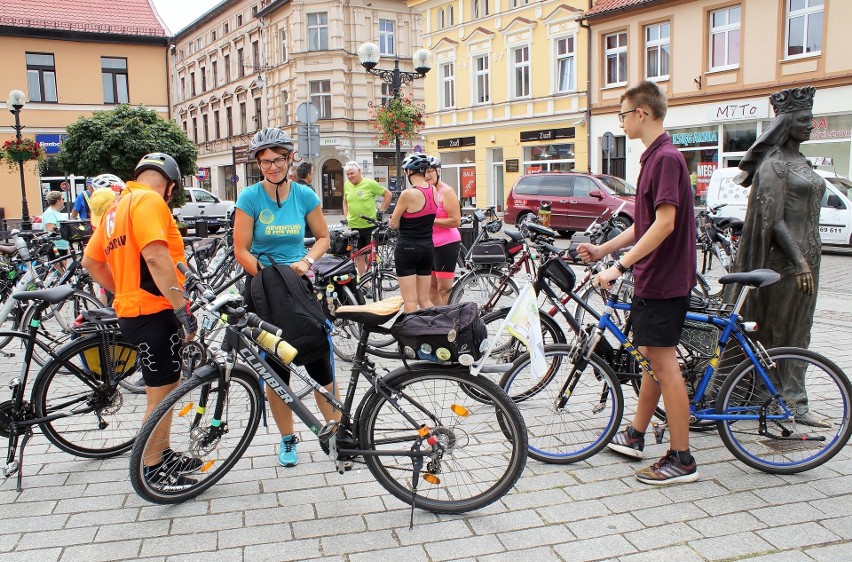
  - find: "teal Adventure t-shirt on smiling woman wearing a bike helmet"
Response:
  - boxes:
[235,182,320,266]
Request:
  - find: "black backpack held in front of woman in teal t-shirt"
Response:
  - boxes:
[251,264,329,365]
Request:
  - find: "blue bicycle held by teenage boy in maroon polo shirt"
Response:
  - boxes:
[501,270,852,474]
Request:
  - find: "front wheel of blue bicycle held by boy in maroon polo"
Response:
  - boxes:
[500,344,624,464]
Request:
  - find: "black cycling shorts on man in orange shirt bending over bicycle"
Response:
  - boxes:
[118,310,183,386]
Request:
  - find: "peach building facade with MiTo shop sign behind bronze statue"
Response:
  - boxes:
[586,0,852,202]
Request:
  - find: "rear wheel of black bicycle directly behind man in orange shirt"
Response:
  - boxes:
[32,333,146,459]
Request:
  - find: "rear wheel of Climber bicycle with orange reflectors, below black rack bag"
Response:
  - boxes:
[358,364,527,513]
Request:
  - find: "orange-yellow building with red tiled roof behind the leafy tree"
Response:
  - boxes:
[0,0,169,227]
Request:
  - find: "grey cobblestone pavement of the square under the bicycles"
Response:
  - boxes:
[0,250,852,562]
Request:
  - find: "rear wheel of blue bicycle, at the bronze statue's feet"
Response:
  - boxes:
[716,347,852,474]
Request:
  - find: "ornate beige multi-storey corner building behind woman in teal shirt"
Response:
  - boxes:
[172,0,423,210]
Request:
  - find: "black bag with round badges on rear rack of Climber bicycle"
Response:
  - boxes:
[391,302,488,363]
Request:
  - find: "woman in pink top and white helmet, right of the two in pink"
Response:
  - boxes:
[426,156,461,306]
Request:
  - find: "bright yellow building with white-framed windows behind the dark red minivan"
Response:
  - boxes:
[408,0,589,209]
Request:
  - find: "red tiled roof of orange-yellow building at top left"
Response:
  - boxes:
[0,0,169,37]
